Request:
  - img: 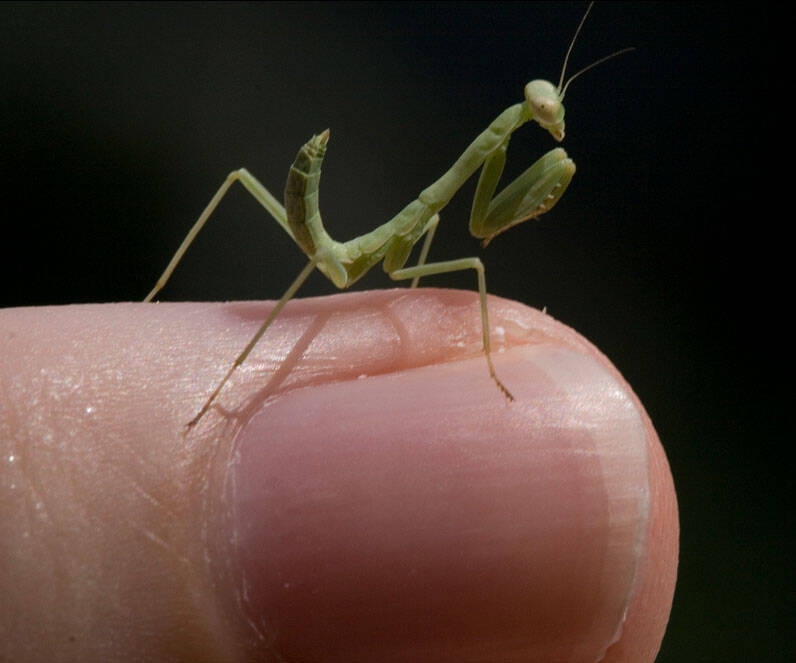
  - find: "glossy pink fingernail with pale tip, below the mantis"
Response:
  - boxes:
[222,342,649,663]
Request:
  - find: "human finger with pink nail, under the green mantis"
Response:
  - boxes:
[0,290,678,663]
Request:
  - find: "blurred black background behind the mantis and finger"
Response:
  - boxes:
[0,3,784,663]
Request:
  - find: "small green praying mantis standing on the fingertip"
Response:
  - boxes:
[144,3,631,429]
